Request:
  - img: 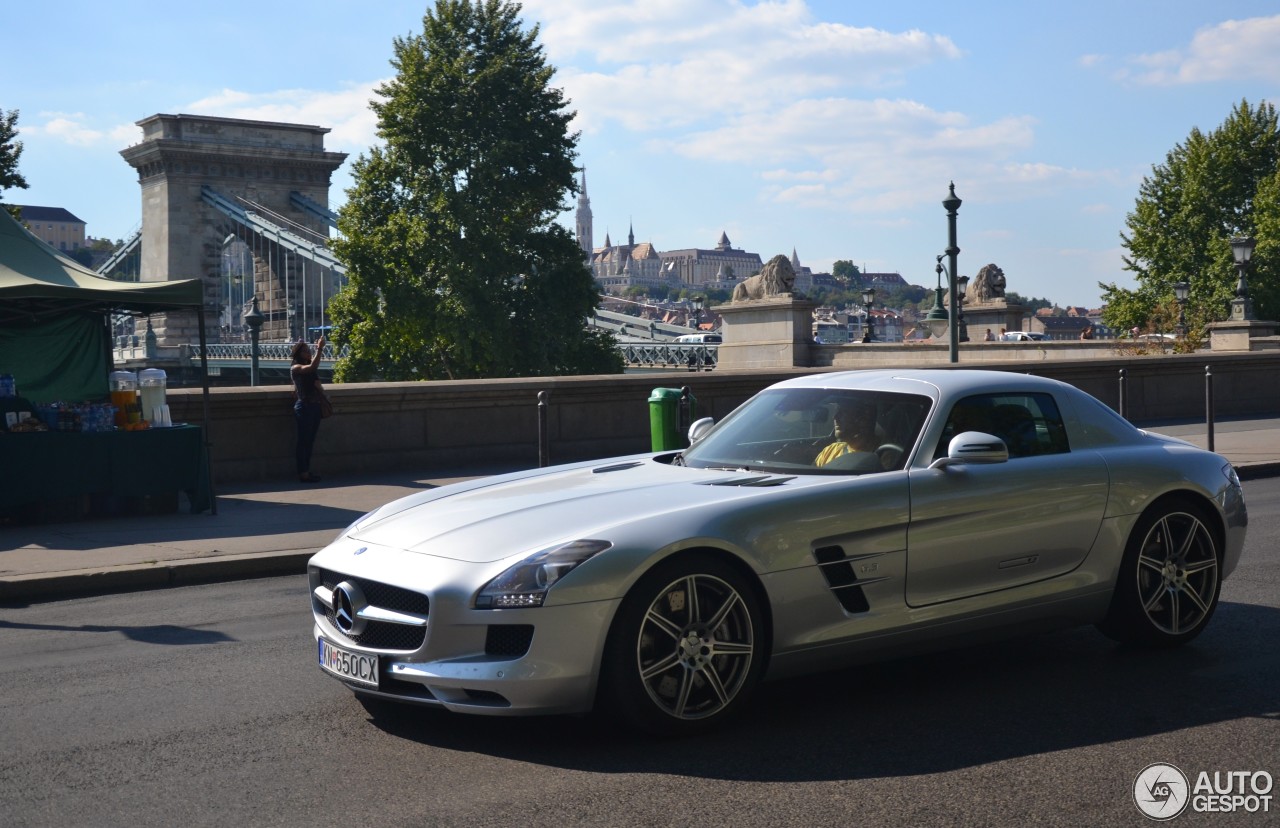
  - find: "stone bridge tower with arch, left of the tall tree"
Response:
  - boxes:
[120,114,347,347]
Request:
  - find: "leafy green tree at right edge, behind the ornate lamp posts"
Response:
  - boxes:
[1098,101,1280,330]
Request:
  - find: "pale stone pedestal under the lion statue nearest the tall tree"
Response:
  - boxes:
[713,294,818,371]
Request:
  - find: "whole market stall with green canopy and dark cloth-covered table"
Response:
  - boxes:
[0,210,216,513]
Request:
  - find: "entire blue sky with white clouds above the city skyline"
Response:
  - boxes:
[0,0,1280,306]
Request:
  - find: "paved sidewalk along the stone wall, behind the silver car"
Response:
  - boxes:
[0,418,1280,604]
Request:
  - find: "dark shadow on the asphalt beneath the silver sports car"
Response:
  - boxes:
[351,603,1280,782]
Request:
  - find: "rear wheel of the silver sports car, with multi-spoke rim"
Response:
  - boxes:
[1098,500,1222,646]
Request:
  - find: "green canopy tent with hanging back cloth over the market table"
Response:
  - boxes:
[0,207,216,513]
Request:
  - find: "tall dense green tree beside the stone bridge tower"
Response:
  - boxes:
[329,0,622,381]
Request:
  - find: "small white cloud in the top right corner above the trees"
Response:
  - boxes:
[1129,15,1280,86]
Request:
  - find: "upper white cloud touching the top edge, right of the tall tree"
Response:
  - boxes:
[525,0,961,132]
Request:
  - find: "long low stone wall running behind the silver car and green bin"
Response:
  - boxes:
[169,343,1280,482]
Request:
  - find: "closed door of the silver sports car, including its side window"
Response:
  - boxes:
[906,393,1110,607]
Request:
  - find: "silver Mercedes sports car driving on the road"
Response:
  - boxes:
[308,370,1248,732]
